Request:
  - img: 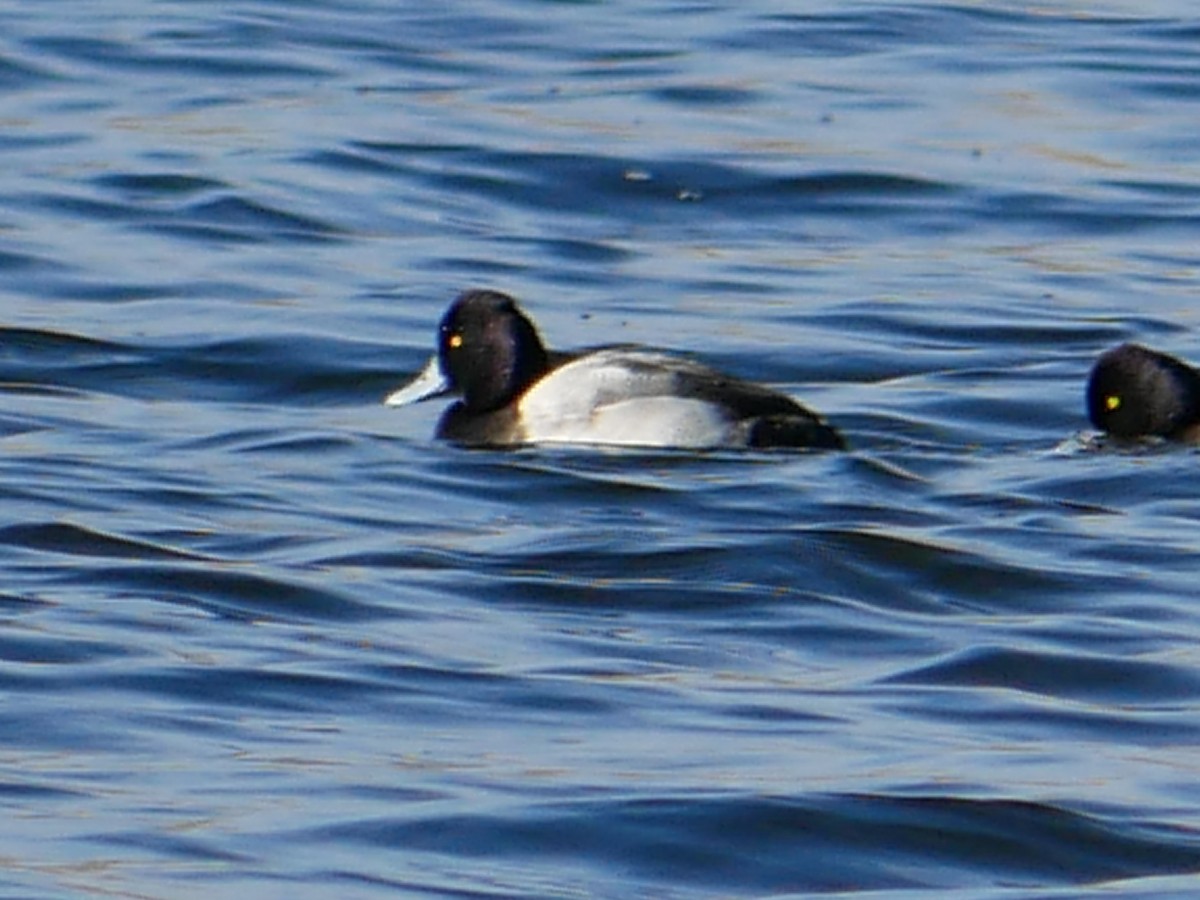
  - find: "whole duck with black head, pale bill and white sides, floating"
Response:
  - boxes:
[384,289,846,450]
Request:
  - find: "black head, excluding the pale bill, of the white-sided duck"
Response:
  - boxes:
[438,290,547,413]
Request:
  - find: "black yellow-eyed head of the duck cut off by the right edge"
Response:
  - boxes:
[1087,343,1200,438]
